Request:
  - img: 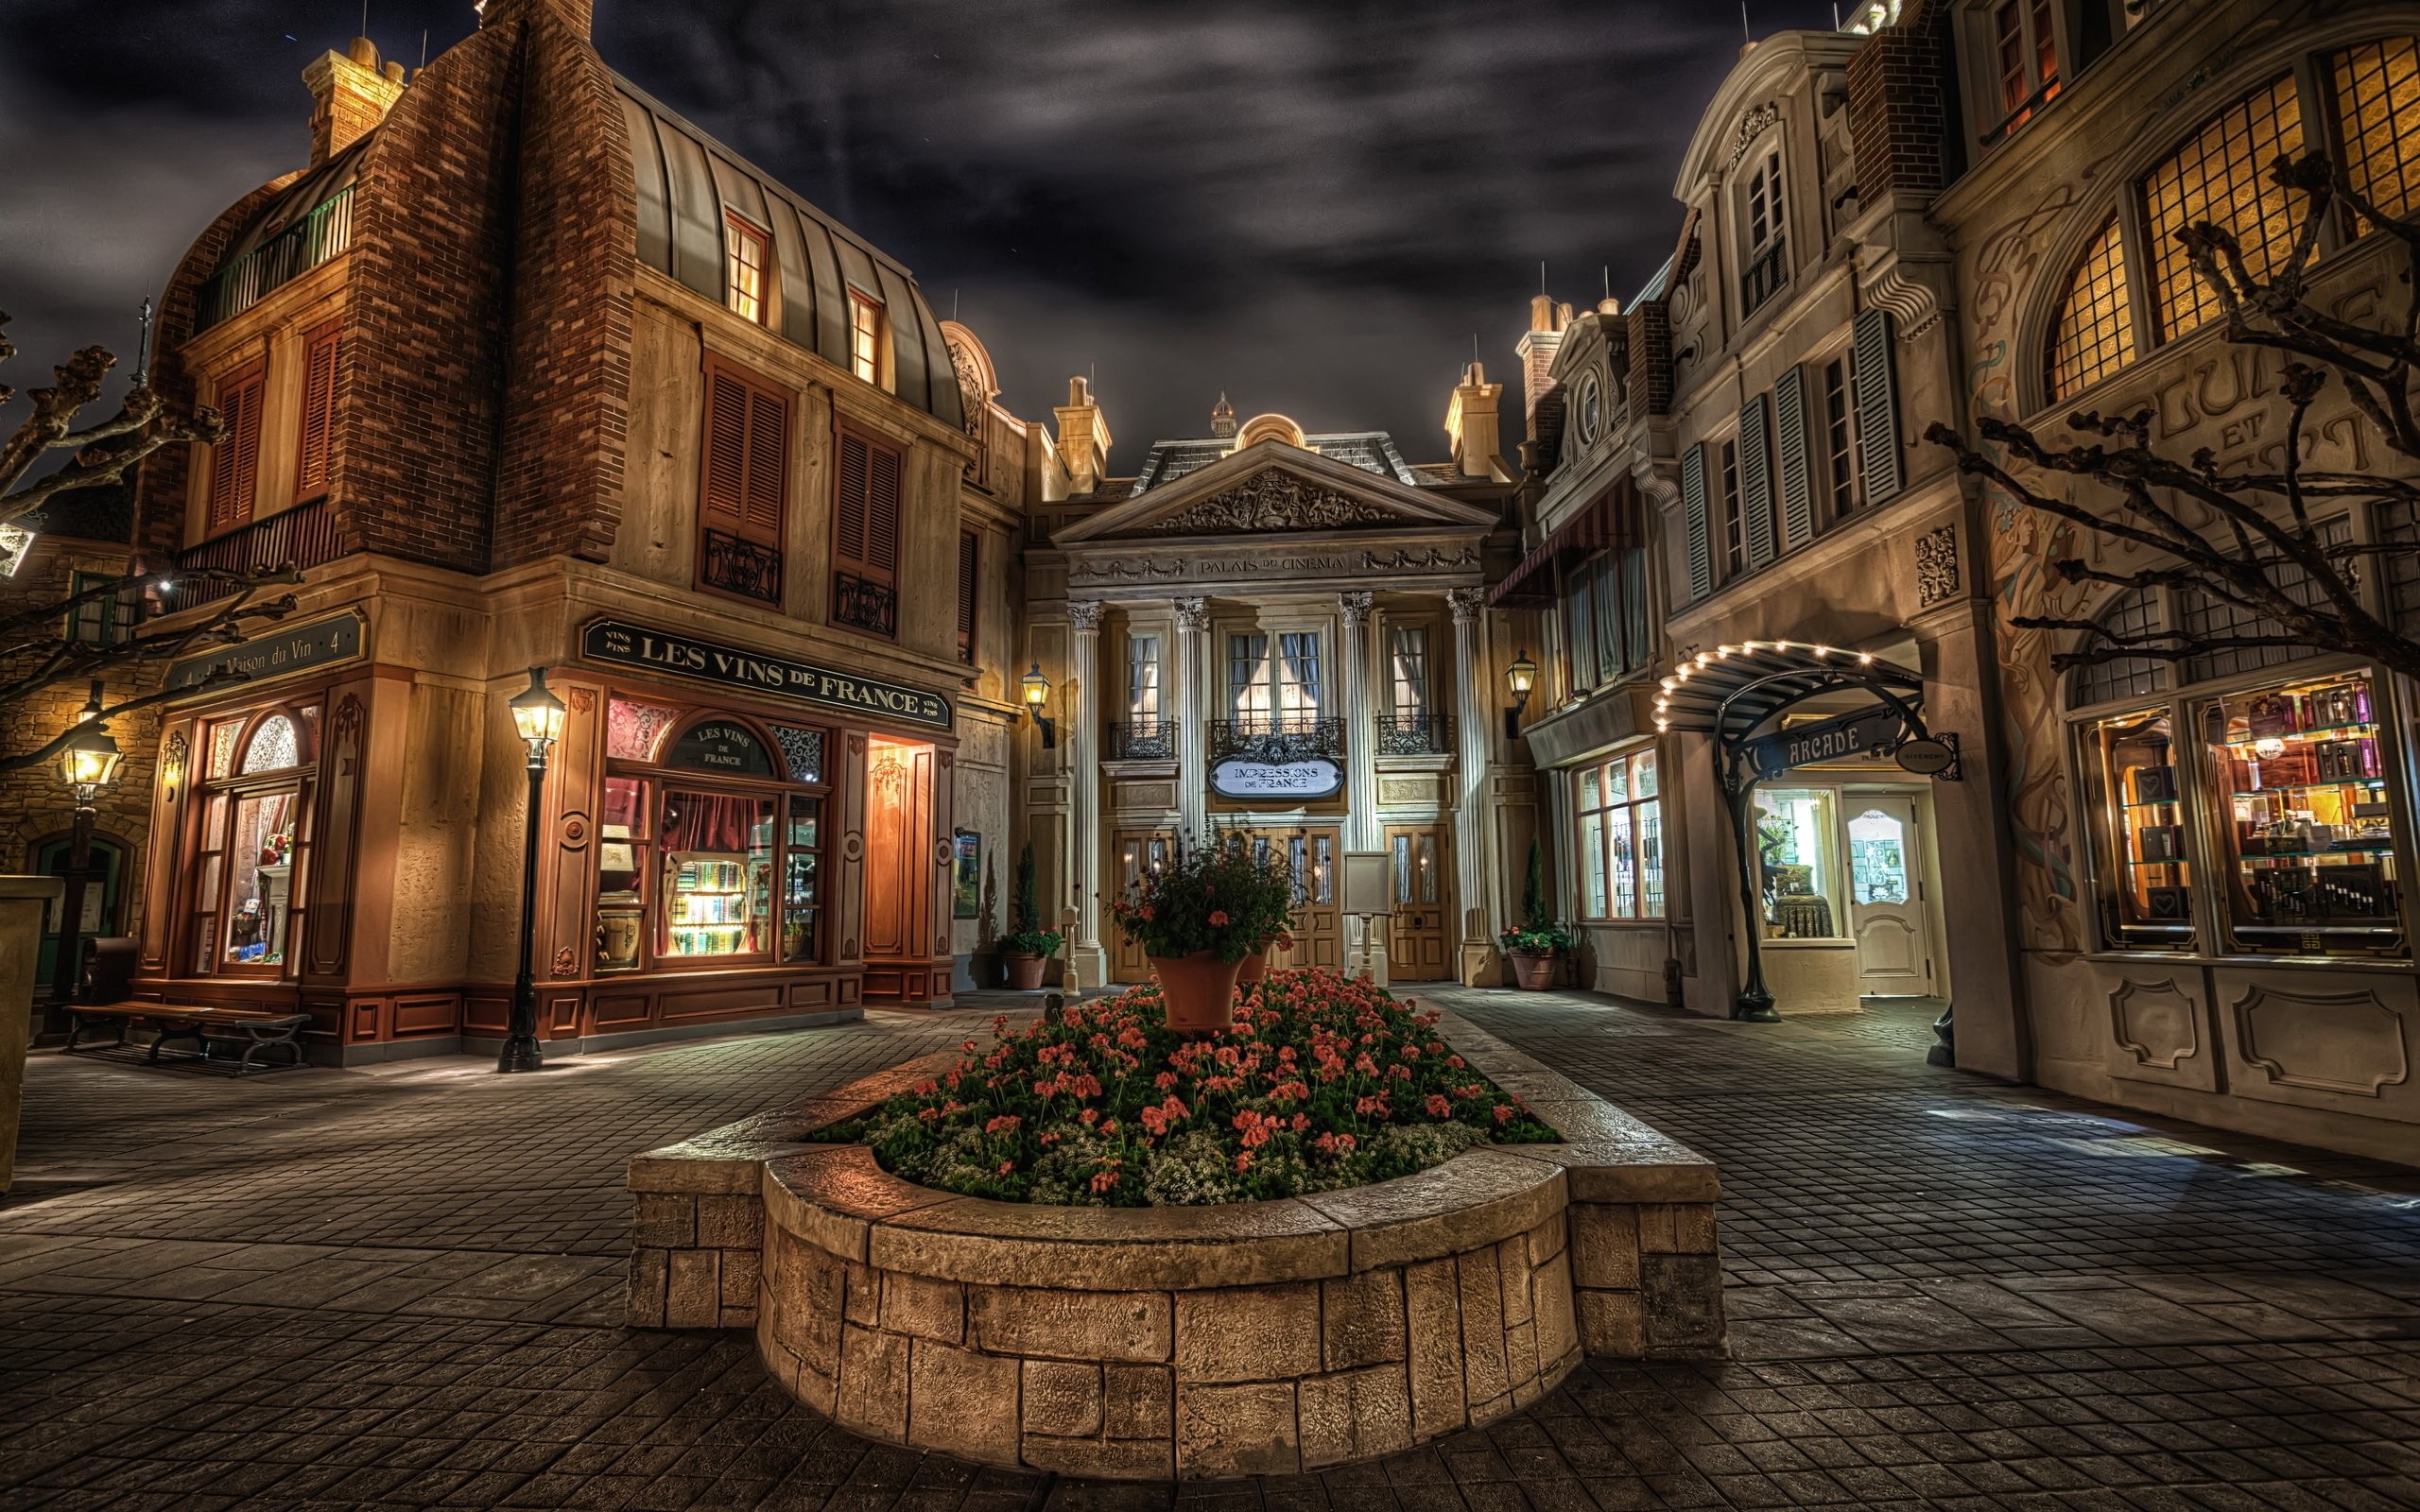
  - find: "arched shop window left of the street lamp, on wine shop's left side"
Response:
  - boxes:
[186,704,320,977]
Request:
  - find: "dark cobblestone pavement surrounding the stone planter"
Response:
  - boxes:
[0,989,2420,1512]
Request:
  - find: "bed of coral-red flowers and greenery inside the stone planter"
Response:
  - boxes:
[821,971,1556,1207]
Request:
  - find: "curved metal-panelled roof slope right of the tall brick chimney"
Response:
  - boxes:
[613,73,965,426]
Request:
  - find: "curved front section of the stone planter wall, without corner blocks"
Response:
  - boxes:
[755,1144,1581,1481]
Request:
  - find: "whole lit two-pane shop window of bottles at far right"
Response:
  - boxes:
[2069,577,2408,955]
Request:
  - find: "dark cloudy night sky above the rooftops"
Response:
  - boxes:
[0,0,1832,474]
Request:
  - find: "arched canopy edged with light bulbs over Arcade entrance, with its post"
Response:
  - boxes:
[1655,641,1948,1021]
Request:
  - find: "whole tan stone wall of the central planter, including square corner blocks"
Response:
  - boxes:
[630,1001,1723,1481]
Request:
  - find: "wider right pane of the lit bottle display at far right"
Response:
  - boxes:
[2203,673,2403,955]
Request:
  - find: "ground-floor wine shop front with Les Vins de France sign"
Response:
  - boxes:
[138,600,956,1064]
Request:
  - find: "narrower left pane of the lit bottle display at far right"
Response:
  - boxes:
[2083,712,2192,951]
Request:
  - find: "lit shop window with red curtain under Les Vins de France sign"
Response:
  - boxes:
[596,699,830,972]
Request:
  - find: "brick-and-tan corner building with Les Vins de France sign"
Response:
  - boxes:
[121,0,1038,1059]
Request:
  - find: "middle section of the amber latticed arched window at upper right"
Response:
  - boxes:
[2142,75,2302,336]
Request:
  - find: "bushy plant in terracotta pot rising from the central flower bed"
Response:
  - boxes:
[1108,834,1295,1033]
